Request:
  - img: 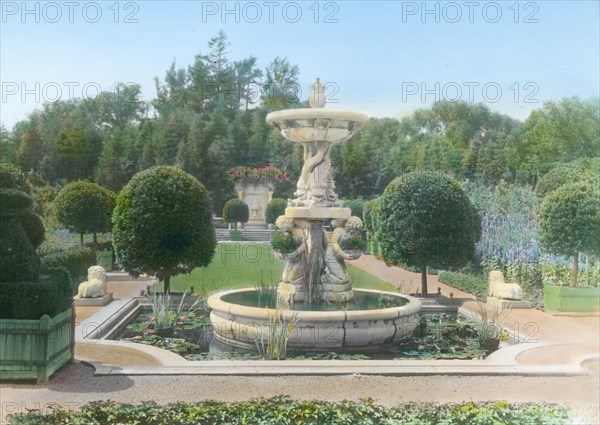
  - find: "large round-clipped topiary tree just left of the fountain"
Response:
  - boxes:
[113,166,217,292]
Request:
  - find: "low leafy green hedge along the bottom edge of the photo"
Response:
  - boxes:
[10,396,572,425]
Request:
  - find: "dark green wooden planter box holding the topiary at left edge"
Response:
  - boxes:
[0,308,75,383]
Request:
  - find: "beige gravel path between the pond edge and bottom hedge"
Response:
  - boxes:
[0,362,600,424]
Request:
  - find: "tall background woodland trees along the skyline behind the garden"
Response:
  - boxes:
[8,31,600,214]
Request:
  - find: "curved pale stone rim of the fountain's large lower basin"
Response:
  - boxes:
[207,288,421,322]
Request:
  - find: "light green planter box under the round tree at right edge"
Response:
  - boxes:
[544,284,600,313]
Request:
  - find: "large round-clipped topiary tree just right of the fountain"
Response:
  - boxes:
[377,172,481,296]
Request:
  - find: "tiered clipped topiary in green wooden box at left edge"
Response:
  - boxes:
[0,164,75,383]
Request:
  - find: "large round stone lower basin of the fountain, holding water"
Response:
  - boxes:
[208,289,421,352]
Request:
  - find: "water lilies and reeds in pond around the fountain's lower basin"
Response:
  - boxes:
[122,313,490,361]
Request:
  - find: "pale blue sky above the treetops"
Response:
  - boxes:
[0,1,600,128]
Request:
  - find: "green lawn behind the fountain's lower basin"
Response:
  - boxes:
[154,242,394,293]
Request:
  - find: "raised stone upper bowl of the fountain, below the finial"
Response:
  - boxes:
[266,108,369,143]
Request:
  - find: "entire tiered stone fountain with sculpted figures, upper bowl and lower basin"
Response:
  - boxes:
[208,80,421,351]
